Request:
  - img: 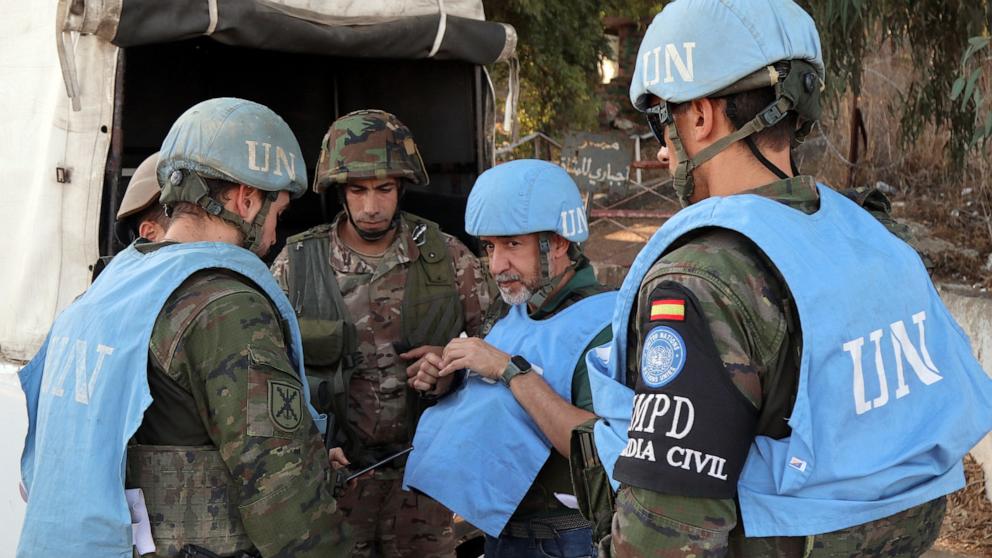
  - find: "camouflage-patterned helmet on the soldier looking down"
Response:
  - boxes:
[313,110,430,192]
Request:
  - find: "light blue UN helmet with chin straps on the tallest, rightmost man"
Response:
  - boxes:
[630,0,824,205]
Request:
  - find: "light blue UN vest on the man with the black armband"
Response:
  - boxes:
[588,185,992,537]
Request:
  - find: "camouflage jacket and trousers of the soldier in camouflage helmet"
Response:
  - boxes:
[272,212,489,558]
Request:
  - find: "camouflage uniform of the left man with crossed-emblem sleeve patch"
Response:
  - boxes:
[128,244,350,558]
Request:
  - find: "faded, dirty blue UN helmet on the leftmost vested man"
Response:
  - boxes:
[157,97,307,251]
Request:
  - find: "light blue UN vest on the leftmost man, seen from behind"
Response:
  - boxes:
[17,242,322,558]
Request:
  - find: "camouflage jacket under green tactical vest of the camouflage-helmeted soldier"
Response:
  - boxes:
[272,212,489,468]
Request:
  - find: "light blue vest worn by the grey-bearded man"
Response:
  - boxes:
[403,292,616,537]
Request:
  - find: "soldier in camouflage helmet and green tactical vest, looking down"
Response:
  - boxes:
[272,110,489,558]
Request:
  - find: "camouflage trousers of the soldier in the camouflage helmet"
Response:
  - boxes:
[338,475,455,558]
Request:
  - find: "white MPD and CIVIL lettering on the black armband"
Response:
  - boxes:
[620,393,727,480]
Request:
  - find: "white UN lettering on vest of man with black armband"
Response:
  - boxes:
[842,312,944,415]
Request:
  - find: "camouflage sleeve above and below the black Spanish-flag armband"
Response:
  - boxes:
[603,231,787,557]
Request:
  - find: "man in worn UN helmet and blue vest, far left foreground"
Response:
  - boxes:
[18,98,350,558]
